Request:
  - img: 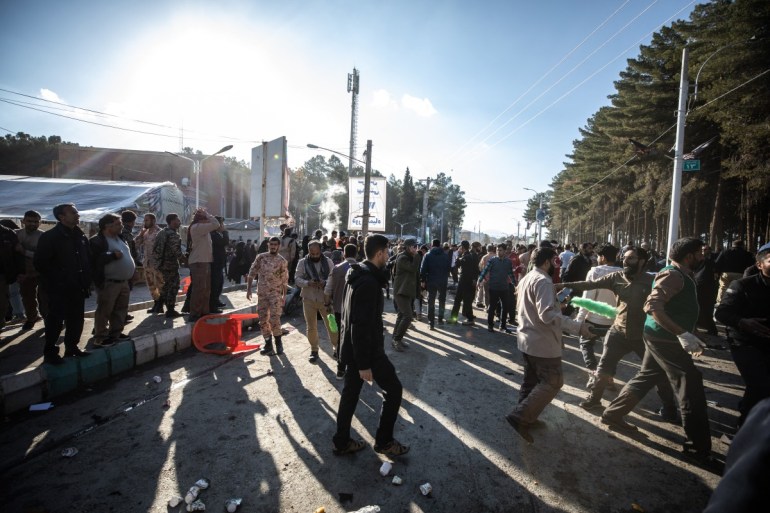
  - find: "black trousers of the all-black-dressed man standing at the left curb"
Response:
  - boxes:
[43,290,86,354]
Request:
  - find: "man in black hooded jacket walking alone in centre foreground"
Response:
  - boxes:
[332,235,409,456]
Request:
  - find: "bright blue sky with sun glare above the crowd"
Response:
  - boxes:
[0,0,695,233]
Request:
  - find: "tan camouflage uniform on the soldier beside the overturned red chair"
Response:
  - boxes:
[249,253,289,337]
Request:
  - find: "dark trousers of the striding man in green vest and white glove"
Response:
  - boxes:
[603,338,711,453]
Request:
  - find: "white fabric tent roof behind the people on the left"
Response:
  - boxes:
[0,175,189,224]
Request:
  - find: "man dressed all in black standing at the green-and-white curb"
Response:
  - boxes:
[33,203,91,365]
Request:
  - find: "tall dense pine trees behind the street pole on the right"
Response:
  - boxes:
[536,0,770,252]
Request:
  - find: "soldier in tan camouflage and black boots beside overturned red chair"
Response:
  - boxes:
[246,237,289,356]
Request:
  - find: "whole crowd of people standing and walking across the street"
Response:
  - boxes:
[0,207,770,492]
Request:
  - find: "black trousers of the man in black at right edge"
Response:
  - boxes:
[730,342,770,426]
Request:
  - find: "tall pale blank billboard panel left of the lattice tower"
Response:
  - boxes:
[249,137,289,218]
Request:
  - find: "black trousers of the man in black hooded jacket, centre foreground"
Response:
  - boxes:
[332,355,402,449]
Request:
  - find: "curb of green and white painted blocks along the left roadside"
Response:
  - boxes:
[0,300,257,415]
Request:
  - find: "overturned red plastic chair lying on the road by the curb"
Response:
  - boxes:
[192,314,262,355]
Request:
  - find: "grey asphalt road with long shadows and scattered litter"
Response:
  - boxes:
[0,291,742,513]
